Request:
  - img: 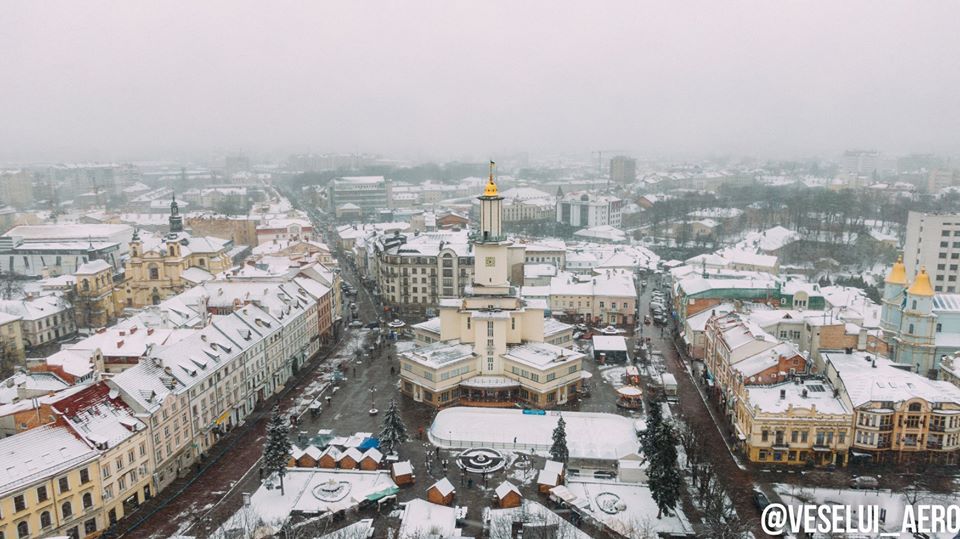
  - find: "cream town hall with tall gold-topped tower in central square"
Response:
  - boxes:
[400,168,583,407]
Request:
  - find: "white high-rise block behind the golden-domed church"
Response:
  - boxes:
[903,211,960,294]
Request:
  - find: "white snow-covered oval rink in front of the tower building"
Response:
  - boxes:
[429,407,640,460]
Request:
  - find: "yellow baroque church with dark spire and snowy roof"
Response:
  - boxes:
[124,200,231,307]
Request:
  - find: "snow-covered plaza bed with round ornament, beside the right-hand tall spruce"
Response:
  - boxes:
[566,479,693,537]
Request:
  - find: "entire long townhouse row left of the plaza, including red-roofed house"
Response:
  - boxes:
[0,276,328,539]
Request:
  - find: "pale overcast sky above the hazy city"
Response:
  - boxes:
[0,0,960,160]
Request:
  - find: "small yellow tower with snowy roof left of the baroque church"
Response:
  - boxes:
[73,260,124,328]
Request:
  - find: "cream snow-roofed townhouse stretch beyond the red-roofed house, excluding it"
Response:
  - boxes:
[108,280,319,489]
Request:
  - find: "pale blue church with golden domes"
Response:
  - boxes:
[880,256,960,377]
